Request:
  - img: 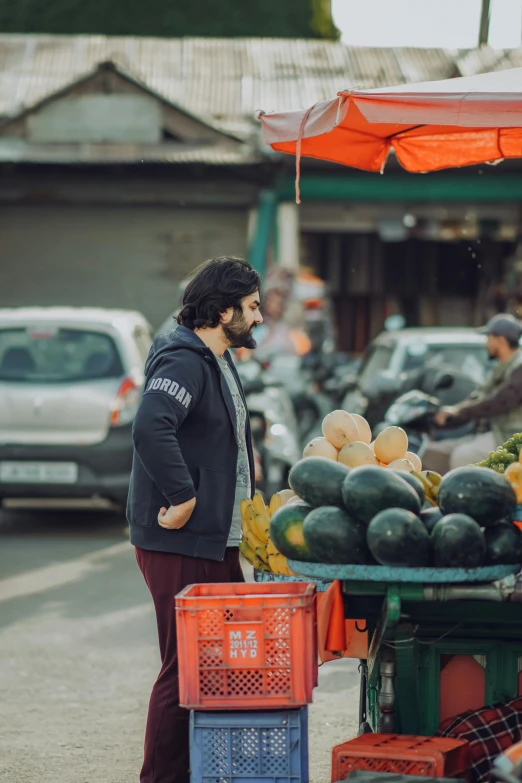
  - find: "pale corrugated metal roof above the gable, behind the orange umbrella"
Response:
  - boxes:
[0,34,522,150]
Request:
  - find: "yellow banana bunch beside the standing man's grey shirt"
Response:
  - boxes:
[239,492,292,576]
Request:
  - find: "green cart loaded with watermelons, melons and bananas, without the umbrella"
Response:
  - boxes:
[241,411,522,756]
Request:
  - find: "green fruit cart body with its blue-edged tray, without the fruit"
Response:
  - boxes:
[256,561,522,736]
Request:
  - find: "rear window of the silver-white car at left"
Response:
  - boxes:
[0,326,124,383]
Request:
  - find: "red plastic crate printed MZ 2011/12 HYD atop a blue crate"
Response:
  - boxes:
[176,582,317,710]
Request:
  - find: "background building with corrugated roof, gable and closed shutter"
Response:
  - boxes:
[0,35,522,352]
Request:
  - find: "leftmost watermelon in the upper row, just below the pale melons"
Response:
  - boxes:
[289,457,350,508]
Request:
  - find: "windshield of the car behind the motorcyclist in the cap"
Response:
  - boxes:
[403,343,489,383]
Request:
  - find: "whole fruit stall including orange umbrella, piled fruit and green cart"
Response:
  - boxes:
[237,64,522,780]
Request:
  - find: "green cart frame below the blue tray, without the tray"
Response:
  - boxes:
[343,581,522,736]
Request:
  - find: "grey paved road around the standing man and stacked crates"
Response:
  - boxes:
[0,511,358,783]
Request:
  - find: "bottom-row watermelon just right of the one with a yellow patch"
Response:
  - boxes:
[303,506,369,565]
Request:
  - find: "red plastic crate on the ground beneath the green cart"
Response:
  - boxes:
[332,734,470,783]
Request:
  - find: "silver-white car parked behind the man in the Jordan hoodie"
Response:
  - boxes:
[0,307,152,507]
